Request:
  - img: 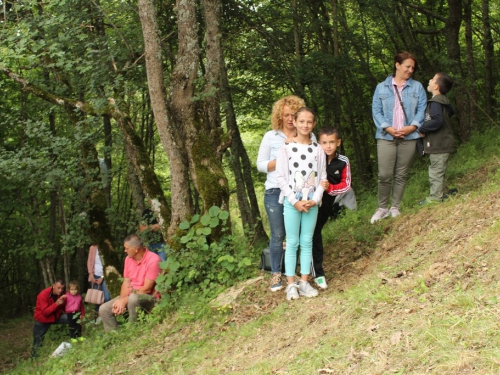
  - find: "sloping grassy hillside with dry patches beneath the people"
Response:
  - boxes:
[4,129,500,374]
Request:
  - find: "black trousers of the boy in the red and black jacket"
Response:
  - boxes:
[312,195,343,278]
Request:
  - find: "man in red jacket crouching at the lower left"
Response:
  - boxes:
[31,279,69,357]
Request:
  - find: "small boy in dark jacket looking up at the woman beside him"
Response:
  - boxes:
[418,73,455,205]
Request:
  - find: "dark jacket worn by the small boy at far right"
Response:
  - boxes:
[418,94,455,154]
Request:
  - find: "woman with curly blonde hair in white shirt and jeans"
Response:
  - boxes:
[257,95,305,292]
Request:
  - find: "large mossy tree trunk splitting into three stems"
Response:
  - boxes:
[138,0,229,226]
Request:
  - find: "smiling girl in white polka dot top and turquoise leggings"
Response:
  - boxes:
[276,107,326,300]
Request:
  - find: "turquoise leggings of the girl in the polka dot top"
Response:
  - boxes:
[283,199,318,276]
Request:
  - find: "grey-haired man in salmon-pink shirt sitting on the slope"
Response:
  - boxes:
[99,234,161,332]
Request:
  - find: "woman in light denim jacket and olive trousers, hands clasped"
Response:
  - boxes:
[371,51,427,224]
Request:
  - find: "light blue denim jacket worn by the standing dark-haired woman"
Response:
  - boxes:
[372,75,427,141]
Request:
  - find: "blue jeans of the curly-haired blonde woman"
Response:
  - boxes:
[264,188,285,273]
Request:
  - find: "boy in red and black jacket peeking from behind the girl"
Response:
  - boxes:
[312,126,357,289]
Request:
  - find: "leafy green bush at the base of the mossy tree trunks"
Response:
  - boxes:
[156,206,252,306]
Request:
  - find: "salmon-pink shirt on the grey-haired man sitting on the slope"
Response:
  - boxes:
[123,249,161,295]
